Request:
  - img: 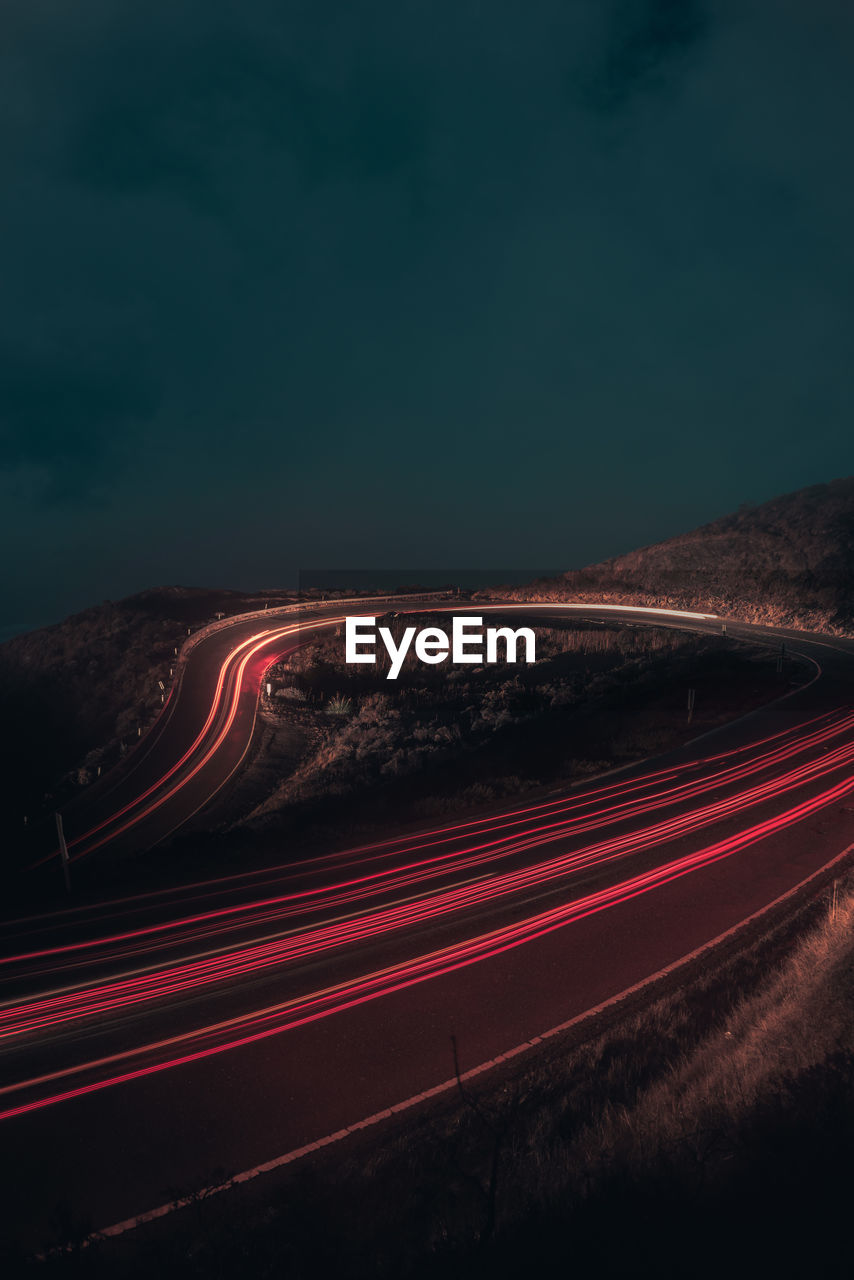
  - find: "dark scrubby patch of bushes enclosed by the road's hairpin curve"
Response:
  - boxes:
[237,614,803,837]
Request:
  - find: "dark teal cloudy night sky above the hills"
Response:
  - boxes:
[0,0,854,631]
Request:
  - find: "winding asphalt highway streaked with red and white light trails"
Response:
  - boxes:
[0,602,854,1248]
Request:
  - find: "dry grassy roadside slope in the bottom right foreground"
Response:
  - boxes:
[31,865,854,1280]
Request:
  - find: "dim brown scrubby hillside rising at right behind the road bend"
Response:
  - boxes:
[512,476,854,632]
